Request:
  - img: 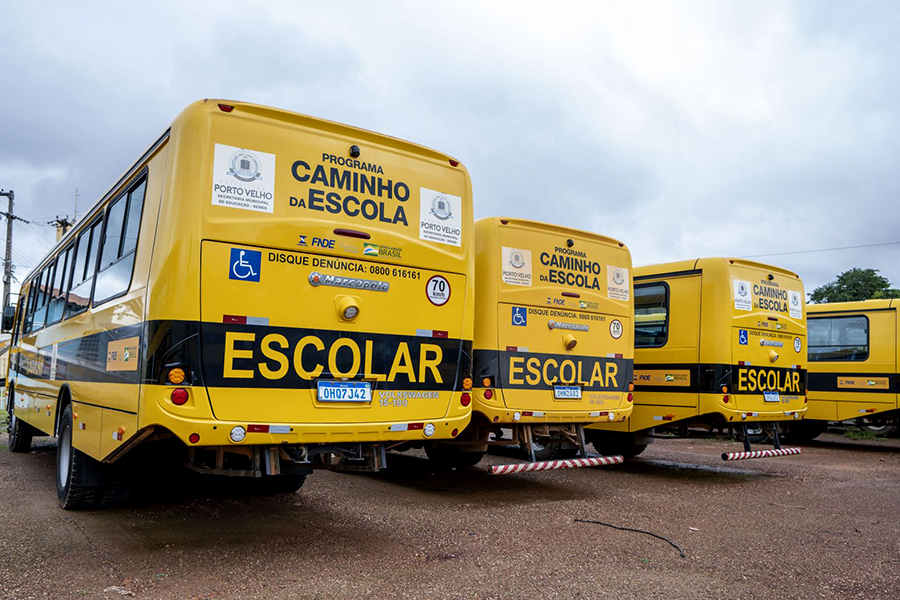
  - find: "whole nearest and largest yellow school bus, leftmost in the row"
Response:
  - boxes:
[1,100,474,508]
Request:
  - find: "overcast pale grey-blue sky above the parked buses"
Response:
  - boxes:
[0,0,900,298]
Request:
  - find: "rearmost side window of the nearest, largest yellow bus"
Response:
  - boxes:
[94,180,147,304]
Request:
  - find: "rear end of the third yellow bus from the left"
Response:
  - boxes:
[716,259,807,437]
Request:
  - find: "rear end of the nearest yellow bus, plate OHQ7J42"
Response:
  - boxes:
[141,101,474,486]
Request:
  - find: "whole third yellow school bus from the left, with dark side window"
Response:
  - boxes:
[588,258,806,458]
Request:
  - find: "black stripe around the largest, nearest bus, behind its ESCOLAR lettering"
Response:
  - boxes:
[13,320,472,391]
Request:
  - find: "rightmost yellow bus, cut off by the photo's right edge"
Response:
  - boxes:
[791,300,900,440]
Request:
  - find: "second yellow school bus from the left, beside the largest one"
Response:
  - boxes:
[429,218,634,466]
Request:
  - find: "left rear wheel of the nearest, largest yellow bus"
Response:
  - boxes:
[56,405,104,510]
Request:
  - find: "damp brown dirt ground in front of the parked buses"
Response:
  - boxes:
[0,434,900,599]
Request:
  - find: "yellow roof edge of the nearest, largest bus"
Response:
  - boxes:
[22,98,464,282]
